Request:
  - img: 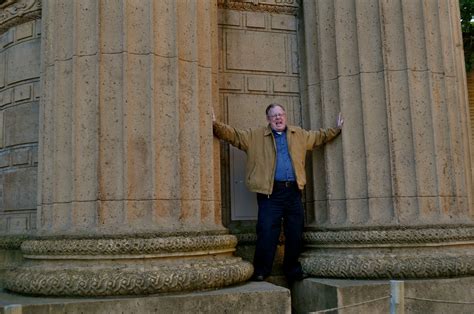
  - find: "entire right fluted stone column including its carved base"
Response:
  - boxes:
[302,0,474,278]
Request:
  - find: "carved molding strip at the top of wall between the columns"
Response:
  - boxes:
[217,0,299,15]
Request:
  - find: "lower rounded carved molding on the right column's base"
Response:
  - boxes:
[301,251,474,279]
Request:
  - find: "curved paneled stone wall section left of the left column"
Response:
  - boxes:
[0,20,41,235]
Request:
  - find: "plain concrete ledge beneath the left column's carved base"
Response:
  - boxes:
[0,282,291,314]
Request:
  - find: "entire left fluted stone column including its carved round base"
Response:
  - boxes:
[6,0,252,296]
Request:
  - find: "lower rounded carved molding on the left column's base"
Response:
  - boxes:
[5,257,253,296]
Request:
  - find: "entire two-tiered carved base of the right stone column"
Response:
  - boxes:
[301,227,474,279]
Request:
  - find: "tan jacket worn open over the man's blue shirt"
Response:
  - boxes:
[213,121,341,195]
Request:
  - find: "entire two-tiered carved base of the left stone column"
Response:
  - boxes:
[5,235,253,296]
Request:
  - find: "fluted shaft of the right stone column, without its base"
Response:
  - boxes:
[302,0,473,229]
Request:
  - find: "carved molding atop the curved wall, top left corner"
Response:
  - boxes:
[0,0,41,34]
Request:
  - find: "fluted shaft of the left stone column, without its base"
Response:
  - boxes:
[38,1,223,235]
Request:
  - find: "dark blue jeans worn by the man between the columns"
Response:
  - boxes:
[254,181,304,281]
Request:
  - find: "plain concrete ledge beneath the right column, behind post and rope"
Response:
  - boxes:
[292,277,474,314]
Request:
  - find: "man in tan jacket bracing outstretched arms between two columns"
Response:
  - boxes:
[213,104,344,283]
